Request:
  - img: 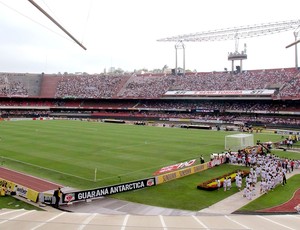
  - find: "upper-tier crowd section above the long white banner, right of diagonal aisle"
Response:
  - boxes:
[118,68,300,98]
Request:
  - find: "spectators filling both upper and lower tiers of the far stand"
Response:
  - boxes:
[0,68,300,125]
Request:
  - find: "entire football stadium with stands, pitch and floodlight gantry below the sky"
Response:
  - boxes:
[0,1,300,230]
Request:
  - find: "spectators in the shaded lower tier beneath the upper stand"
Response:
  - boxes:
[0,98,300,125]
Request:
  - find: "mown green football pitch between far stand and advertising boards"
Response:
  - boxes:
[0,120,292,188]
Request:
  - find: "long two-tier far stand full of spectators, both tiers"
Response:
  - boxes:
[0,68,300,129]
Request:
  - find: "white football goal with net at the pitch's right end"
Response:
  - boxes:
[225,133,254,151]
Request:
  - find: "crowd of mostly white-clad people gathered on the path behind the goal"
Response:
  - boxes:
[216,148,300,200]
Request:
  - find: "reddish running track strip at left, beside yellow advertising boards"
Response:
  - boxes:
[0,167,62,192]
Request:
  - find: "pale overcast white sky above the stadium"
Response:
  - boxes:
[0,0,300,74]
